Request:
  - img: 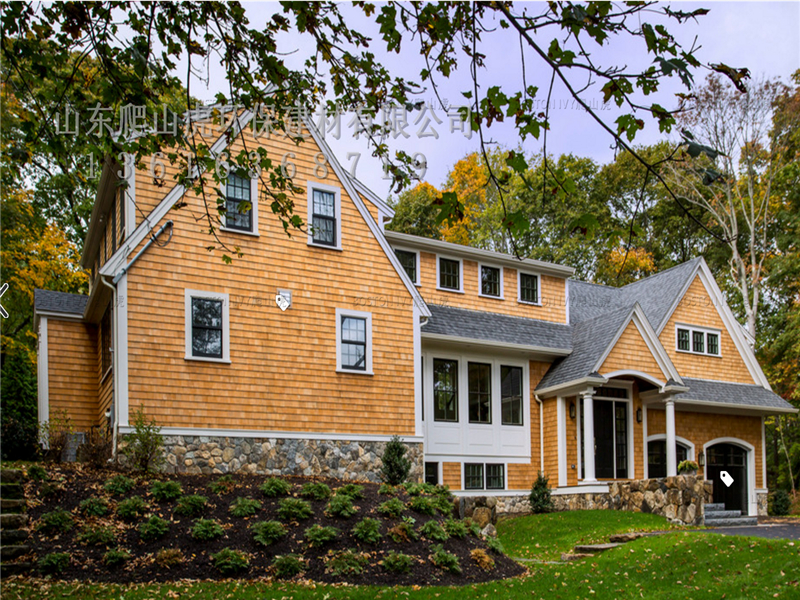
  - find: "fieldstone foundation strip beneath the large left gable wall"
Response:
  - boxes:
[155,435,423,483]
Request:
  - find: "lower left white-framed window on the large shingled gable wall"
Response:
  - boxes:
[184,290,231,363]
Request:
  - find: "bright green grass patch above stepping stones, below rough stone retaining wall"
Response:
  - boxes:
[497,510,681,561]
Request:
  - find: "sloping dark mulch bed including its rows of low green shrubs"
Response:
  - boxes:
[20,465,524,585]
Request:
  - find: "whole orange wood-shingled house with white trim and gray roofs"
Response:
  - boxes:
[35,115,795,515]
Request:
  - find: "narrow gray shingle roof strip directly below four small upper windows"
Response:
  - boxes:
[422,304,572,350]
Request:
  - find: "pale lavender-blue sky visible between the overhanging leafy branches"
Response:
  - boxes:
[183,1,800,198]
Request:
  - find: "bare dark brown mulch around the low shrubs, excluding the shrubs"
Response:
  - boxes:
[22,465,525,585]
